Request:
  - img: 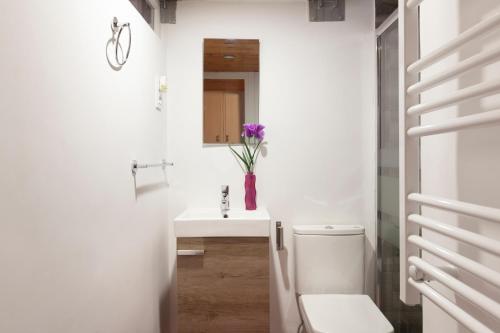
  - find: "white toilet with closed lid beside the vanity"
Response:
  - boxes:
[293,225,394,333]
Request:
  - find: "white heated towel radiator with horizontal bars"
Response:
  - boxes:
[398,0,500,333]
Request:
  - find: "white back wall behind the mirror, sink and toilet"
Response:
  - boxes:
[163,0,376,332]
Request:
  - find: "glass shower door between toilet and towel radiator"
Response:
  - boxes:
[376,21,422,333]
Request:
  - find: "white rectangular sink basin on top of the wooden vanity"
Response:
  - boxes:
[174,208,271,237]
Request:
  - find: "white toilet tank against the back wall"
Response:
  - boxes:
[293,225,365,295]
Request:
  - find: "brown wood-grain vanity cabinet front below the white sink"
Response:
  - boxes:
[177,237,269,333]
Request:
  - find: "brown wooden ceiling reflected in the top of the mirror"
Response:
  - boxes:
[203,39,259,72]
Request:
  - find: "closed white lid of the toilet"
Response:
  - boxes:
[299,294,394,333]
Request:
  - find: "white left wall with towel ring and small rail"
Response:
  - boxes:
[0,0,168,333]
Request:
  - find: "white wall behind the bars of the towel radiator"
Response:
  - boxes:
[420,0,500,333]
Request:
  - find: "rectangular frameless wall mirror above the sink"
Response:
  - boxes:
[203,39,259,144]
